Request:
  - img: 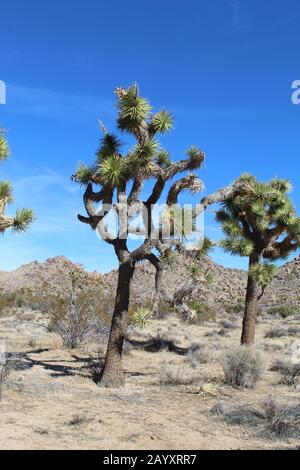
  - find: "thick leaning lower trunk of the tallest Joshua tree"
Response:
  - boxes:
[100,261,134,387]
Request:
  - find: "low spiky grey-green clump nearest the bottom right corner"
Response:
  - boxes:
[223,396,300,439]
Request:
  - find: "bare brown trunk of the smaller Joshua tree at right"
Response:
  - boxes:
[241,255,259,345]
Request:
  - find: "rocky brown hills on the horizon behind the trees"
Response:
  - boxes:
[0,255,300,305]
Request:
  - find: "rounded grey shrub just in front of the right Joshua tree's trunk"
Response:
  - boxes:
[221,346,265,388]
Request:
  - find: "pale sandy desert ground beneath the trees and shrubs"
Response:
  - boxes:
[0,302,300,450]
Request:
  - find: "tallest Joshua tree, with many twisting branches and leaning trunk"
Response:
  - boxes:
[73,84,246,387]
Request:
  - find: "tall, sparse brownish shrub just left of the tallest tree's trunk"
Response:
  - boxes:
[47,270,108,349]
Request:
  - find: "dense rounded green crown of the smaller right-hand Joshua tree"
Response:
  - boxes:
[216,173,300,260]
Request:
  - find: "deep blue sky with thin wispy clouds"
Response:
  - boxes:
[0,0,300,271]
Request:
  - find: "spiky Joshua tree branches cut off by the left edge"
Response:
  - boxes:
[0,129,34,233]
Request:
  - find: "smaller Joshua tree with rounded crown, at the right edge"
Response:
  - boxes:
[216,174,300,344]
